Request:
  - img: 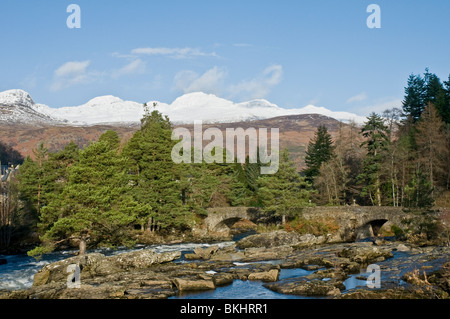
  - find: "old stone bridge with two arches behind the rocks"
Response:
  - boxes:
[204,206,418,240]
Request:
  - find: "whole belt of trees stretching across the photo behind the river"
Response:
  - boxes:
[0,69,450,255]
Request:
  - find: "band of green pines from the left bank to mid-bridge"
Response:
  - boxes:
[6,106,311,255]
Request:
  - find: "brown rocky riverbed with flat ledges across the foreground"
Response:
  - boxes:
[0,231,450,299]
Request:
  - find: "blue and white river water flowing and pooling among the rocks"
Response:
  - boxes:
[0,238,448,299]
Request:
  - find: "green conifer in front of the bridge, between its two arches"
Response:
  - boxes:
[258,149,311,224]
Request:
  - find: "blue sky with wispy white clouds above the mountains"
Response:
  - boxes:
[0,0,450,116]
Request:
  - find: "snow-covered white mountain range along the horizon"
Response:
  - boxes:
[0,90,366,125]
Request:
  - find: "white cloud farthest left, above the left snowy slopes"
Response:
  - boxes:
[50,60,94,91]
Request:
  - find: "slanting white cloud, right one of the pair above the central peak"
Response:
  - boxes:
[229,64,283,99]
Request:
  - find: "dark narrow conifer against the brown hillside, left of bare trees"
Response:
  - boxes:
[304,125,334,183]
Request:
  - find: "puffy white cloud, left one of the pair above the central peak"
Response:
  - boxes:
[174,66,227,95]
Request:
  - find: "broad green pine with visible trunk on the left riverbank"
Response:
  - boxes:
[29,132,139,255]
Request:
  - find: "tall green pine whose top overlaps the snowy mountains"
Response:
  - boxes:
[123,108,191,229]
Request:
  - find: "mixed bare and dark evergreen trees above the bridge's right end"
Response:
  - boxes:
[303,69,450,207]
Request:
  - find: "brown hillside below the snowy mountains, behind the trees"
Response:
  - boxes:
[0,114,358,170]
